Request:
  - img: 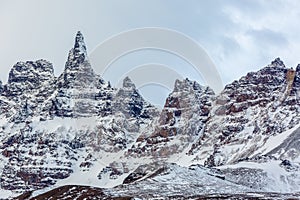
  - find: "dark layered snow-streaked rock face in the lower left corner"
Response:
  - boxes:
[0,120,78,192]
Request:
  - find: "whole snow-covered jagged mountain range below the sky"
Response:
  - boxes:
[0,32,300,199]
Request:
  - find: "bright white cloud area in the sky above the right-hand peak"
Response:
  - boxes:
[210,1,300,83]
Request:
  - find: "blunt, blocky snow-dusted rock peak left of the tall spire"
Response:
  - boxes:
[1,60,56,123]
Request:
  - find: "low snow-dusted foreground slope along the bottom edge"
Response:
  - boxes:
[22,161,300,199]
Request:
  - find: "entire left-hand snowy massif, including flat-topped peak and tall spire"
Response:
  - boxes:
[0,32,158,192]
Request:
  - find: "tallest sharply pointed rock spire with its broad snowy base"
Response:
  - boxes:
[50,32,115,117]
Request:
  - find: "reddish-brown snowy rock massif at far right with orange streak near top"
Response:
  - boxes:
[190,59,299,166]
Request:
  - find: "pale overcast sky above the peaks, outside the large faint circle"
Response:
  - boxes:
[0,0,300,100]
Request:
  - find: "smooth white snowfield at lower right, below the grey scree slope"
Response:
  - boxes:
[218,159,300,193]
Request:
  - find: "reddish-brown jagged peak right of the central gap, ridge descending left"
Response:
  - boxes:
[130,79,214,158]
